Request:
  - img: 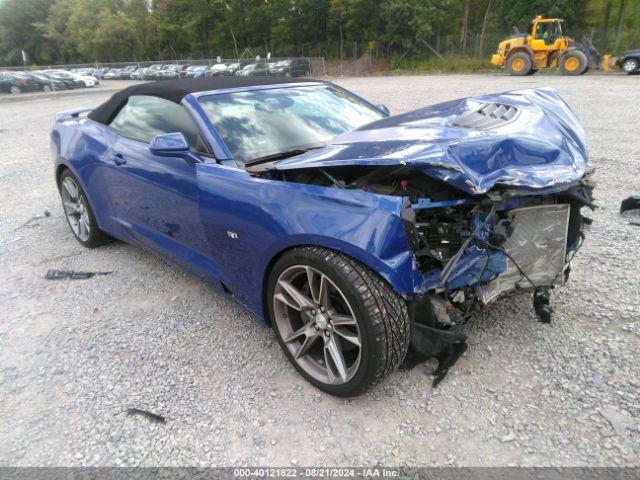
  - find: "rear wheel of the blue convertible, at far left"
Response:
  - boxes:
[59,170,110,248]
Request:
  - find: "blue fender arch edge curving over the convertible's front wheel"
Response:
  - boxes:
[260,235,414,325]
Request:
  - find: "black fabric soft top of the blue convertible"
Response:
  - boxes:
[88,76,321,124]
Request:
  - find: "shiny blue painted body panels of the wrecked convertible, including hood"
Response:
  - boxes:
[52,84,586,320]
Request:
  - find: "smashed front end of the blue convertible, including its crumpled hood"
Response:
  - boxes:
[248,89,594,385]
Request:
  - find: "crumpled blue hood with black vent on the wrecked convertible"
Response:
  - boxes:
[275,88,587,194]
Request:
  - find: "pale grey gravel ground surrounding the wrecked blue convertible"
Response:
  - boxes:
[0,75,640,466]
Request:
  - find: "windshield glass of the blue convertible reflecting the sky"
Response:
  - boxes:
[200,85,383,164]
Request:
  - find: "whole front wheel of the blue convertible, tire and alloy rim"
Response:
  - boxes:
[267,247,410,397]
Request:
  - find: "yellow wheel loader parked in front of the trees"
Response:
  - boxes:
[491,16,600,75]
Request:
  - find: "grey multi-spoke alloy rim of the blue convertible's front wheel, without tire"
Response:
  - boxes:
[273,265,362,385]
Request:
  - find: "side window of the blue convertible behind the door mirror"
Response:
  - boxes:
[109,95,205,151]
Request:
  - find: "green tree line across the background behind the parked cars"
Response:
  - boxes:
[0,0,640,66]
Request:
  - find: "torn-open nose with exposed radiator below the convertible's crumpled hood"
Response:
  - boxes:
[406,177,593,385]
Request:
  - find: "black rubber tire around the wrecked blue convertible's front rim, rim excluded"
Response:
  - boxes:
[267,247,410,397]
